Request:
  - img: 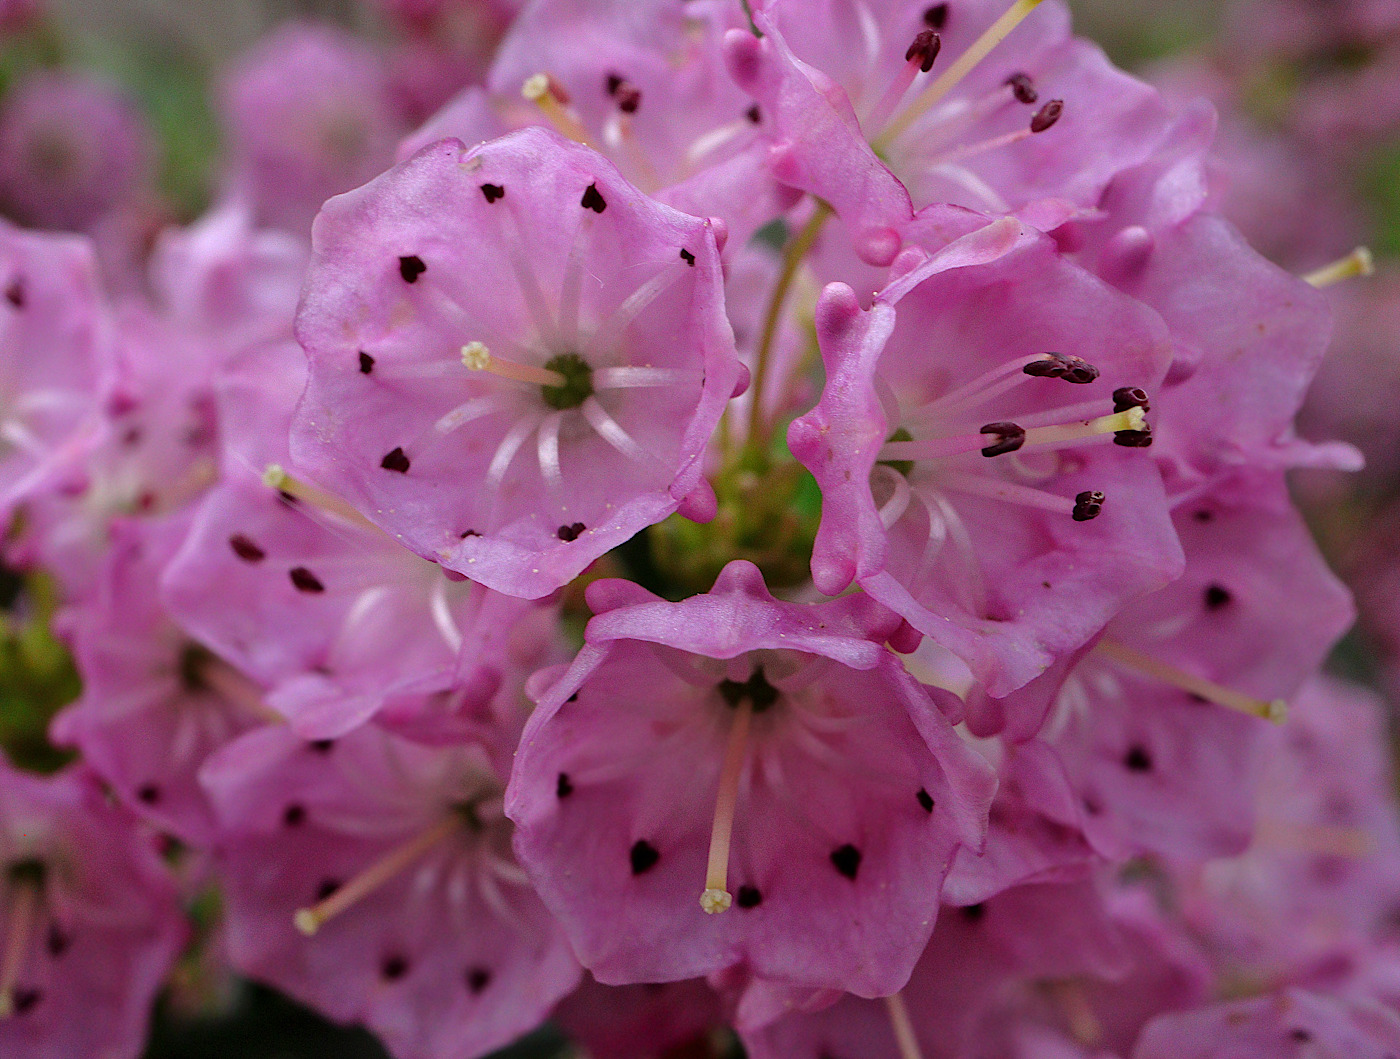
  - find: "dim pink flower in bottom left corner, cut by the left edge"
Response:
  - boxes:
[0,758,186,1059]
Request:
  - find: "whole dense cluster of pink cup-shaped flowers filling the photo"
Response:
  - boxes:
[0,0,1400,1059]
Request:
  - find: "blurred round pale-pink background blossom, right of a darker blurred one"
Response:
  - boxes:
[223,24,402,234]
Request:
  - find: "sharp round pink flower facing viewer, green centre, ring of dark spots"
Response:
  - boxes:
[293,129,742,598]
